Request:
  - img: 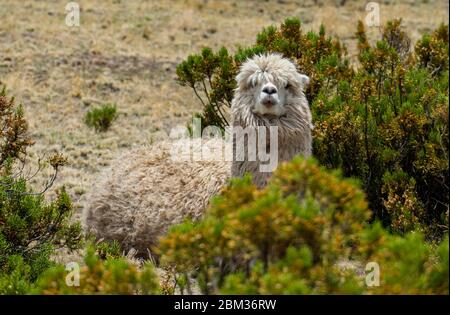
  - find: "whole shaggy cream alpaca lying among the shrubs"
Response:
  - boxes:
[83,54,312,256]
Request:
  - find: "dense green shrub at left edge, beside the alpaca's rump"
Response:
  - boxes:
[0,172,81,294]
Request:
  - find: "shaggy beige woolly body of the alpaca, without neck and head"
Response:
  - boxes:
[83,140,231,256]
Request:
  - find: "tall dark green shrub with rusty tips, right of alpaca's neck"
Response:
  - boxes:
[312,21,449,239]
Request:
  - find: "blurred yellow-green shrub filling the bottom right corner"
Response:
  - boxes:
[360,224,449,294]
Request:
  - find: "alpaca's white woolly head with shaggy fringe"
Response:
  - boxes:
[232,54,309,118]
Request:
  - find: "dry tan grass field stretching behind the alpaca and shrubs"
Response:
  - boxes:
[0,0,448,222]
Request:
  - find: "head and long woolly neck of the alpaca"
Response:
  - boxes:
[231,54,313,188]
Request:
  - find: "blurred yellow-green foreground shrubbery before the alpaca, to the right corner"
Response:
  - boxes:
[159,158,448,294]
